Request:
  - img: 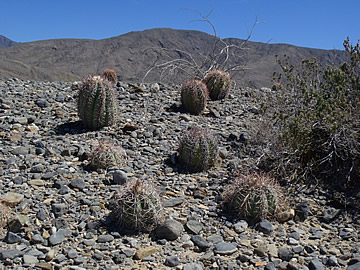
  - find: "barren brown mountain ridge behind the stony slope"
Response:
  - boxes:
[0,28,345,87]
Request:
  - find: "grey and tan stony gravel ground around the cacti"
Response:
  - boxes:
[0,79,360,270]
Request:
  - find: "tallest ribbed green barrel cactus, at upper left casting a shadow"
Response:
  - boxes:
[78,76,118,129]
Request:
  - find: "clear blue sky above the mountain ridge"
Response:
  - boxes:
[0,0,360,49]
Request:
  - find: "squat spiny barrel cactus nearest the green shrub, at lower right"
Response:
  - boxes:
[224,173,284,220]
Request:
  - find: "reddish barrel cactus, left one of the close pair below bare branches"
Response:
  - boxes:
[181,79,208,115]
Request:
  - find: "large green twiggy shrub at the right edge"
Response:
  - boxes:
[265,39,360,188]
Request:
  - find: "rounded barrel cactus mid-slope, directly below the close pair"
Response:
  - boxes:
[178,126,218,172]
